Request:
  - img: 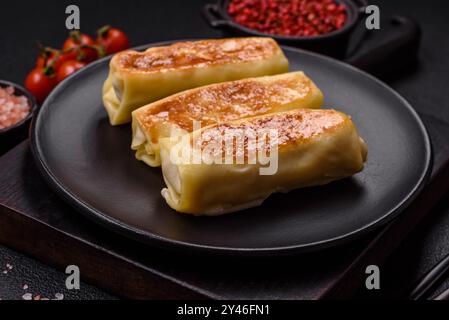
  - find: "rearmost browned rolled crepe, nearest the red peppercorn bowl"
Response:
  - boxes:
[103,38,288,125]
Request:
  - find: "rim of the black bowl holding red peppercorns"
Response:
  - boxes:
[217,0,365,43]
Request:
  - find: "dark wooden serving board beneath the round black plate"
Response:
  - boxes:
[0,111,449,299]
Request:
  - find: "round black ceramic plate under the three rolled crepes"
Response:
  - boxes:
[32,43,431,256]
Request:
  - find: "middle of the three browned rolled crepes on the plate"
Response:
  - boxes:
[131,72,323,167]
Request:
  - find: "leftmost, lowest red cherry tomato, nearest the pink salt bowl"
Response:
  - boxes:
[25,68,56,103]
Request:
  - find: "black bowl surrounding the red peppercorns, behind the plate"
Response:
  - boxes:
[203,0,367,58]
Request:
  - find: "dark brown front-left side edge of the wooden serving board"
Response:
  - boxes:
[0,205,210,300]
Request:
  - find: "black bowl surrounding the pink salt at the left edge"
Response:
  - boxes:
[0,80,37,156]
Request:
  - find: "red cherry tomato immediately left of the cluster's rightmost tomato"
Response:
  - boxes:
[62,31,98,63]
